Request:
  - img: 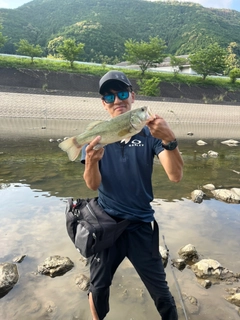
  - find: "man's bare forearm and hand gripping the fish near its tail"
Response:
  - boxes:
[83,136,104,191]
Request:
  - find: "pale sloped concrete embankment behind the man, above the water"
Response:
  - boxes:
[0,92,240,138]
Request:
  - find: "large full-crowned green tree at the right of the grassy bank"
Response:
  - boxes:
[189,42,227,80]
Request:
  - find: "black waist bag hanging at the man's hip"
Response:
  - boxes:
[66,198,130,258]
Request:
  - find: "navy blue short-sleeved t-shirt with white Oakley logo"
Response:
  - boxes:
[81,126,163,222]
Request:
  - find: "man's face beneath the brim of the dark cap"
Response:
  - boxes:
[102,90,135,118]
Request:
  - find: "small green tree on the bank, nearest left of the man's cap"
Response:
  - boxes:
[57,39,84,68]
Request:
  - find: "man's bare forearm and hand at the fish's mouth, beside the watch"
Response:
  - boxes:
[147,115,183,182]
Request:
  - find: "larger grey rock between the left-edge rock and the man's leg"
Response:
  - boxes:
[38,255,74,278]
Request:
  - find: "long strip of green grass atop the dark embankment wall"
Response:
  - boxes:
[0,56,240,92]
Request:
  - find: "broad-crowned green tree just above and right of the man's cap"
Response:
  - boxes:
[124,37,166,76]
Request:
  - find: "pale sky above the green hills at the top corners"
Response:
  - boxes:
[0,0,240,12]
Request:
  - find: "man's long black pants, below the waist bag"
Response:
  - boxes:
[89,223,178,320]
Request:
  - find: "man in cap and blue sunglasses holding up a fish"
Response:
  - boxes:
[81,71,183,320]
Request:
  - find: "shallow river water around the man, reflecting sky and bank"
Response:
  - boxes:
[0,137,240,320]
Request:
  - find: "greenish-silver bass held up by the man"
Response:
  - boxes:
[58,106,155,161]
